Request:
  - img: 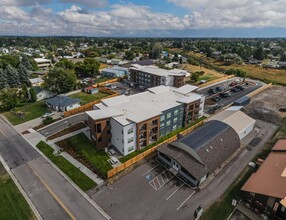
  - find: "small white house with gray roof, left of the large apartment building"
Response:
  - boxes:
[45,96,82,112]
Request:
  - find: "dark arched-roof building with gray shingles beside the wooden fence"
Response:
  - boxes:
[157,120,240,187]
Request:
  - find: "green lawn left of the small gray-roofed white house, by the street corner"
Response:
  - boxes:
[4,101,47,125]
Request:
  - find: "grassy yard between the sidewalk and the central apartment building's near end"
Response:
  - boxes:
[56,133,112,177]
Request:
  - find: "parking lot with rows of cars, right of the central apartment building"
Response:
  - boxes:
[198,78,264,114]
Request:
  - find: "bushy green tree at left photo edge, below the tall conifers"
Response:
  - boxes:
[0,88,17,111]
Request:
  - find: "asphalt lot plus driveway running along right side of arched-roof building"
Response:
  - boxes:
[92,121,277,220]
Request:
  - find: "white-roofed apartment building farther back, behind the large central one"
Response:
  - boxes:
[128,64,190,88]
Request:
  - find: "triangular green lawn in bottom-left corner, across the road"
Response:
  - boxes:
[0,163,36,220]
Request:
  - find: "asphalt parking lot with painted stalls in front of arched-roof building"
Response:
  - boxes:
[92,159,196,220]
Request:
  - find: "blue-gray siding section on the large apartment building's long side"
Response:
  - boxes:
[160,104,184,137]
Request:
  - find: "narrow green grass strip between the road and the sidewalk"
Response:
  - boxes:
[37,141,96,191]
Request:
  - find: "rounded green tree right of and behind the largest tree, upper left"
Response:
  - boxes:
[75,57,100,77]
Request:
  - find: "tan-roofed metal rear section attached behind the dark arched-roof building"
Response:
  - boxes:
[209,106,255,140]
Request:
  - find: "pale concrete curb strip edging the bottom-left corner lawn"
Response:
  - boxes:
[0,155,43,220]
